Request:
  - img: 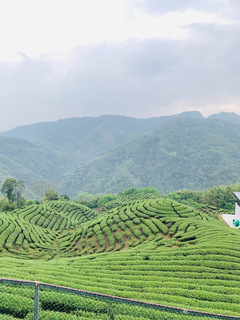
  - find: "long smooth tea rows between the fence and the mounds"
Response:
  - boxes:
[0,236,240,315]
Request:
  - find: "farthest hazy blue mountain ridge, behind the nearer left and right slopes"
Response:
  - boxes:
[1,112,202,169]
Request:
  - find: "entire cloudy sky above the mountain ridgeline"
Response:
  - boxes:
[0,0,240,131]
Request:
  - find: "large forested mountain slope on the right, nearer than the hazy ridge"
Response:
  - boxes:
[63,118,240,194]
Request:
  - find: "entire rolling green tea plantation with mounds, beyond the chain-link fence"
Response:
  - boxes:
[0,197,240,319]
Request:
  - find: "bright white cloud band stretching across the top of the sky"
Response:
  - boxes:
[0,0,233,61]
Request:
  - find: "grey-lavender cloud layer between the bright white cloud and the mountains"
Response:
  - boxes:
[0,0,240,131]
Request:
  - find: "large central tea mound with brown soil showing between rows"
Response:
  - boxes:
[58,198,228,255]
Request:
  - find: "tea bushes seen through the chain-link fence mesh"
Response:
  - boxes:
[0,284,238,320]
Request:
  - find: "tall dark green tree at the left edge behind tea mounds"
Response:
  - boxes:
[1,177,25,205]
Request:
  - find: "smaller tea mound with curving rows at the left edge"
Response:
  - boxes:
[0,201,97,258]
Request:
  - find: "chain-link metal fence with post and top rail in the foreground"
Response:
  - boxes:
[0,279,240,320]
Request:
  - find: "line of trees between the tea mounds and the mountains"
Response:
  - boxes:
[0,177,237,211]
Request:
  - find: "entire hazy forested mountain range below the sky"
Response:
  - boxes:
[0,112,240,196]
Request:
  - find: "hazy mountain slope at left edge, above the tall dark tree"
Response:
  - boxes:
[0,136,68,185]
